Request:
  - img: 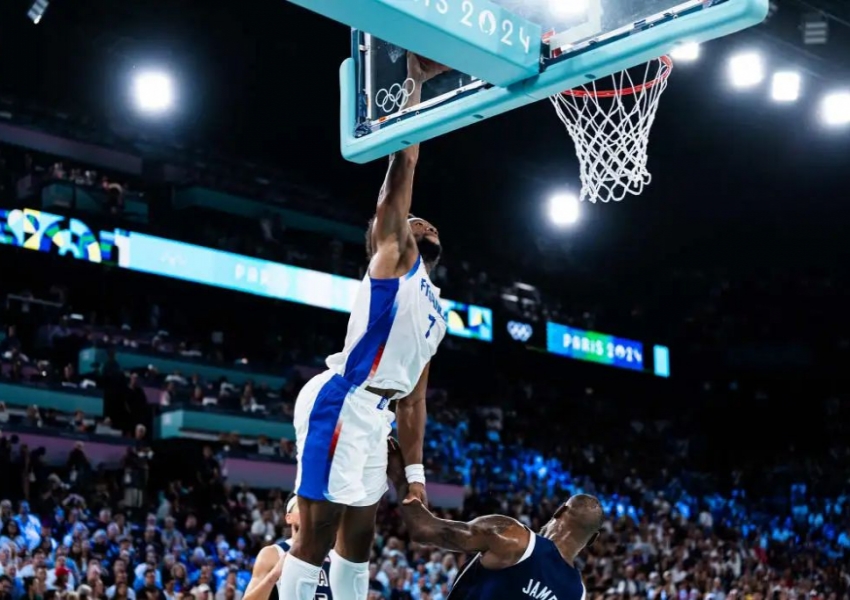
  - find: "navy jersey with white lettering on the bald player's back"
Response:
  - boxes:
[447,533,584,600]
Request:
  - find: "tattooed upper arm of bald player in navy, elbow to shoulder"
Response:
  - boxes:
[401,502,528,554]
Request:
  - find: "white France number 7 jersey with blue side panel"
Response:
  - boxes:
[327,257,447,397]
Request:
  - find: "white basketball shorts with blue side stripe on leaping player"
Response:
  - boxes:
[293,371,395,506]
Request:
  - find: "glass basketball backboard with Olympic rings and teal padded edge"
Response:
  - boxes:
[334,0,768,162]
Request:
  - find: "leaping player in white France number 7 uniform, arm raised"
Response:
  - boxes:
[279,55,446,600]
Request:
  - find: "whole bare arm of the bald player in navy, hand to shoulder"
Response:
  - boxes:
[387,440,531,568]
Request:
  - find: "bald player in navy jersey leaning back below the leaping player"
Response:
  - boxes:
[387,440,603,600]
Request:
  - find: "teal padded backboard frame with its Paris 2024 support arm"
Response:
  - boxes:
[291,0,769,163]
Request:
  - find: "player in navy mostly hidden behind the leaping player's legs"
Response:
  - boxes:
[243,493,333,600]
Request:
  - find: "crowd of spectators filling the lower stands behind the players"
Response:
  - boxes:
[0,286,850,600]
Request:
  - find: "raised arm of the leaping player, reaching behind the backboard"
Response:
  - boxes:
[371,53,447,270]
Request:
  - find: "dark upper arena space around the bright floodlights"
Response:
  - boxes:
[0,0,850,278]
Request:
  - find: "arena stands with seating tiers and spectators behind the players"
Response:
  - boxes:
[0,131,850,600]
